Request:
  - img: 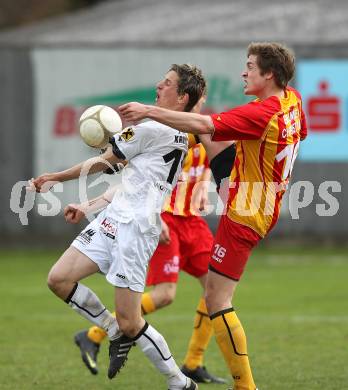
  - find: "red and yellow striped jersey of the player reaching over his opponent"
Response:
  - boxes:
[211,87,307,237]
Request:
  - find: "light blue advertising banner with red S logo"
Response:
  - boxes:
[296,60,348,162]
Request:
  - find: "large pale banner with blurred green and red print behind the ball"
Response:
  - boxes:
[32,48,247,203]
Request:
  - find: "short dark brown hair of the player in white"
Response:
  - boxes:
[169,64,207,112]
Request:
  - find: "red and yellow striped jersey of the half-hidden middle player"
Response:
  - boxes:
[163,144,209,217]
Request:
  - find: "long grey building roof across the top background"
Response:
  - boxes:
[0,0,348,48]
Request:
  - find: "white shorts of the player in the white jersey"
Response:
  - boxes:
[71,210,159,292]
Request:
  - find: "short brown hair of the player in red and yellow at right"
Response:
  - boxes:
[248,42,295,88]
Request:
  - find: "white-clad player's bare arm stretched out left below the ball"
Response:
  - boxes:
[27,147,125,192]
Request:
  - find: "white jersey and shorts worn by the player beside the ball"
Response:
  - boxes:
[72,121,188,293]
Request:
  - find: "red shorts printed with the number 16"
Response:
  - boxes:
[209,215,261,280]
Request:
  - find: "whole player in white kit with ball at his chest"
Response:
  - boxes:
[31,64,206,390]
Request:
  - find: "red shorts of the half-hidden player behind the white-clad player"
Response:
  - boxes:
[146,212,214,286]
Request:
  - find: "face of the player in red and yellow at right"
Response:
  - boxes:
[242,55,269,97]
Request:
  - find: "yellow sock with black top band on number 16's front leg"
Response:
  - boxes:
[210,308,256,390]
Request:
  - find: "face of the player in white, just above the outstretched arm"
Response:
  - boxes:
[156,70,182,110]
